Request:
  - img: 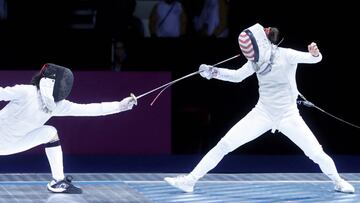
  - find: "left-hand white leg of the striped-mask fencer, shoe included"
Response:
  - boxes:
[165,108,271,192]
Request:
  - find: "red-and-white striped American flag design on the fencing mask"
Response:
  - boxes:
[238,30,259,62]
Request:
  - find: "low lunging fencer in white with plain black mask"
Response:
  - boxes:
[0,63,137,194]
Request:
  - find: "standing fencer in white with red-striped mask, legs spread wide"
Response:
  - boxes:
[165,24,355,193]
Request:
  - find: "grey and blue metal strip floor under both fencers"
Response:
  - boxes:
[0,173,360,203]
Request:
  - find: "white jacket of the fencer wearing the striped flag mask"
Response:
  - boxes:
[215,47,322,117]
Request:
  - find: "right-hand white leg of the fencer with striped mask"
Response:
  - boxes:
[279,114,355,193]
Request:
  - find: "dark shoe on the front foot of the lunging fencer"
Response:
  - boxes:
[47,176,82,194]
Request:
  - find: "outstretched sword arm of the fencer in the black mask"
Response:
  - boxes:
[53,94,137,116]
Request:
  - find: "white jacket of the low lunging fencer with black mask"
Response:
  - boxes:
[0,85,128,143]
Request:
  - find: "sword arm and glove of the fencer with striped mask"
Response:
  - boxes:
[199,62,255,82]
